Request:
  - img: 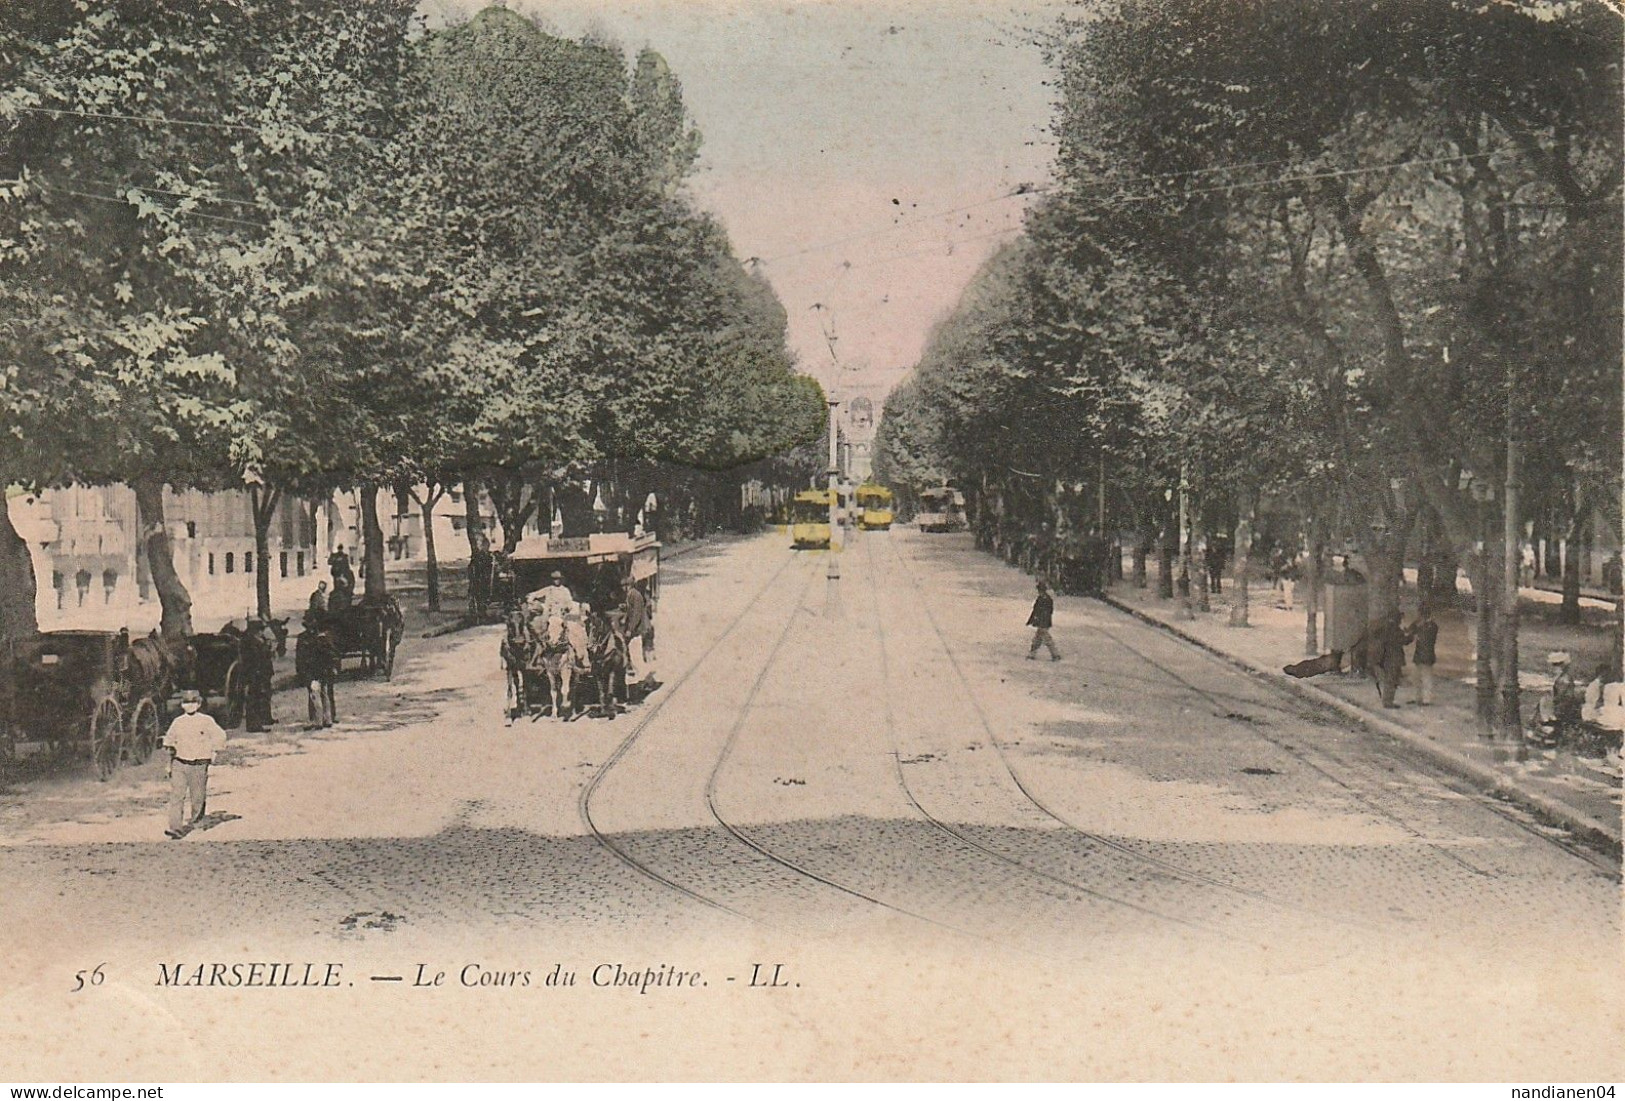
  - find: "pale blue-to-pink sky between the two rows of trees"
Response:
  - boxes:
[424,0,1060,408]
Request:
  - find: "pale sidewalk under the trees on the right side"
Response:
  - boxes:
[1103,580,1620,849]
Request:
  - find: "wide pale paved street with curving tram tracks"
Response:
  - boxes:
[0,529,1620,1072]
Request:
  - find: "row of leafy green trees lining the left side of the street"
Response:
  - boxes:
[0,0,824,637]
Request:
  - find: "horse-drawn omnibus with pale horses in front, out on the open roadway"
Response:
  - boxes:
[502,533,660,721]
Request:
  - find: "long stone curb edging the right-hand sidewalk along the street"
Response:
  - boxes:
[1095,594,1622,859]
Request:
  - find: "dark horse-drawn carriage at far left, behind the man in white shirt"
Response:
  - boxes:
[0,630,174,779]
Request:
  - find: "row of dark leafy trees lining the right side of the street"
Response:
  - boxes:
[878,0,1622,740]
